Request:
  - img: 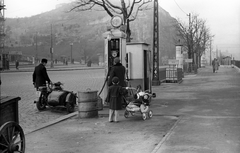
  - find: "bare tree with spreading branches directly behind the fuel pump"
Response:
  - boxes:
[71,0,152,42]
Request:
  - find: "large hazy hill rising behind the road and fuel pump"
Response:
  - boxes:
[5,4,177,64]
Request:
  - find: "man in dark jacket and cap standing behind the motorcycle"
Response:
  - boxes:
[32,59,51,90]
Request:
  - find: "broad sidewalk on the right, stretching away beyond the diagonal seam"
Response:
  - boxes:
[152,66,240,153]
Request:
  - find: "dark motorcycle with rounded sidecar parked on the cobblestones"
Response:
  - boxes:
[35,82,77,113]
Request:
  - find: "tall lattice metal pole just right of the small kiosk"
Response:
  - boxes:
[152,0,161,86]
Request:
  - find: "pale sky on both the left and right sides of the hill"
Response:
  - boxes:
[3,0,240,60]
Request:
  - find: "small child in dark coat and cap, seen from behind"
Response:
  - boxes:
[106,77,123,122]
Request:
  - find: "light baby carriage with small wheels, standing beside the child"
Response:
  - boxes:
[124,86,156,120]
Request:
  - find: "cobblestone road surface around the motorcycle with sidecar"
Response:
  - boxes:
[1,69,104,133]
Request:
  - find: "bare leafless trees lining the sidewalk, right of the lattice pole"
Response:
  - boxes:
[178,14,213,67]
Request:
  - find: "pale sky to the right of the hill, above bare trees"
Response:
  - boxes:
[159,0,240,60]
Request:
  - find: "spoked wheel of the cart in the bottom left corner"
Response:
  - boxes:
[0,121,25,153]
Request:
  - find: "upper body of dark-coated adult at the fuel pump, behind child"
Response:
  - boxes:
[108,57,127,87]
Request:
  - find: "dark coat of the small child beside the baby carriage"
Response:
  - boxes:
[106,84,123,110]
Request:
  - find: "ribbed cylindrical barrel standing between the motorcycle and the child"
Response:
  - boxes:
[78,89,98,118]
